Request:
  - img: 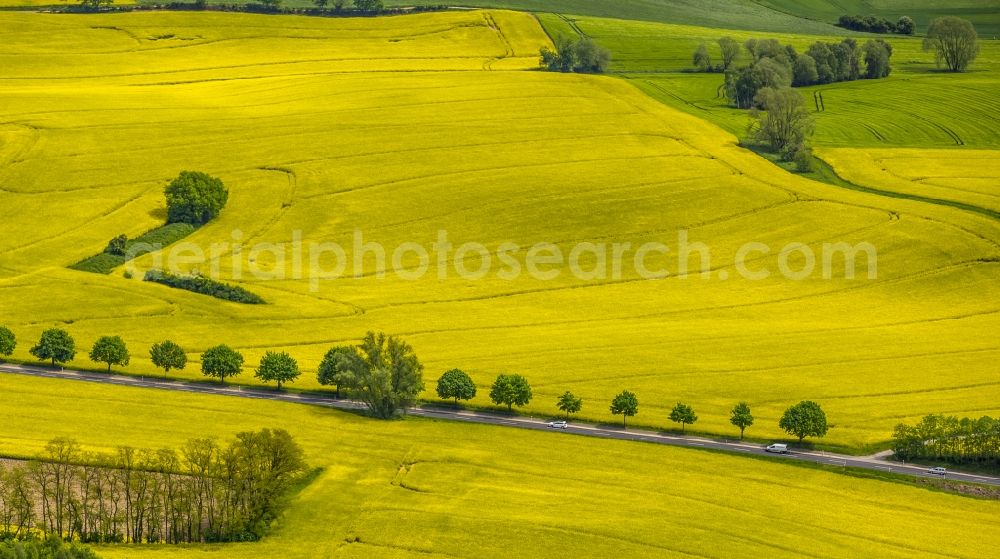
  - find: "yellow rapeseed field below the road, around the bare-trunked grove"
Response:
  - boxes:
[0,375,1000,559]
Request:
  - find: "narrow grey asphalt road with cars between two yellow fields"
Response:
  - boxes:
[0,364,1000,486]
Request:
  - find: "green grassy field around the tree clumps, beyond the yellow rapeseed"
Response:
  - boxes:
[539,12,1000,148]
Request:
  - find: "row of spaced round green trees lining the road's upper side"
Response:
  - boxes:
[0,327,827,441]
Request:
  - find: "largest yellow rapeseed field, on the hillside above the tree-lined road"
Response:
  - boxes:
[0,11,1000,447]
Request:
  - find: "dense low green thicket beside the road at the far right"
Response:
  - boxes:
[892,415,1000,467]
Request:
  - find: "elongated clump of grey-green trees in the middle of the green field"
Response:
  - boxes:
[708,37,892,109]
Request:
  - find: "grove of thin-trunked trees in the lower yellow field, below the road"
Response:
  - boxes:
[0,429,306,543]
